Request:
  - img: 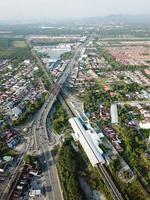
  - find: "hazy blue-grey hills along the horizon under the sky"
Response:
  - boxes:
[0,14,150,26]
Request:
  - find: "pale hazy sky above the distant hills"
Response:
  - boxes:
[0,0,150,20]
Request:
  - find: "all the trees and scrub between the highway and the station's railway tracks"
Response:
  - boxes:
[57,139,112,200]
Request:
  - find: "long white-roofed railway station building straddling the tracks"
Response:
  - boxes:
[69,117,105,166]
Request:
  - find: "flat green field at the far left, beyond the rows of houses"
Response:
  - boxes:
[0,38,31,58]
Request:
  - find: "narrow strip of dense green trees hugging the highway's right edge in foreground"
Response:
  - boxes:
[57,139,84,200]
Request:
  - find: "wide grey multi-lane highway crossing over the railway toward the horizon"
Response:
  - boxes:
[28,39,82,200]
